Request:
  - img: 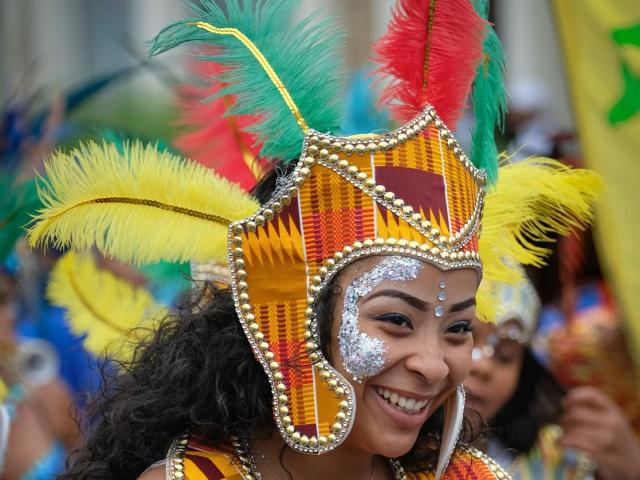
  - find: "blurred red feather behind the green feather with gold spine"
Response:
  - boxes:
[174,55,267,190]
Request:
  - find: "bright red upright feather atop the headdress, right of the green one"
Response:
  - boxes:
[374,0,486,129]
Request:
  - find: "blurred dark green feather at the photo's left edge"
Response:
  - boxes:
[0,173,42,263]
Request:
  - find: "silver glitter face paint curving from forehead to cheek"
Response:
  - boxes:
[338,256,422,381]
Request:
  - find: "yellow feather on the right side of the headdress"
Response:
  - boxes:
[476,158,603,320]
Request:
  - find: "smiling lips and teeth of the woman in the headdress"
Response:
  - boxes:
[367,385,433,427]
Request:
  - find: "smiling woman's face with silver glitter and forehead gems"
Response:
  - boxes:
[331,256,478,457]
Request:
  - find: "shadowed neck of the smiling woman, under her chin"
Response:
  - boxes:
[249,433,393,480]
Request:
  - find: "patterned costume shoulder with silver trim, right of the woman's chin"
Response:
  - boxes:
[407,445,511,480]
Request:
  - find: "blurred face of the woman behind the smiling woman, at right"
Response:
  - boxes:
[464,321,525,422]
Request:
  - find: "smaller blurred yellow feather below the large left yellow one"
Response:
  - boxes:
[47,252,168,361]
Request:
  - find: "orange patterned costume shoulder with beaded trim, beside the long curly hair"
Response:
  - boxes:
[161,436,244,480]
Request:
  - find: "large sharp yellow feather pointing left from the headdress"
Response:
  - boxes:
[29,142,258,264]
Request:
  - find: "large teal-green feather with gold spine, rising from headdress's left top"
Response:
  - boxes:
[150,0,344,160]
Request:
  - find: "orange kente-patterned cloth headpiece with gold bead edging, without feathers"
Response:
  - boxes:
[229,107,484,453]
